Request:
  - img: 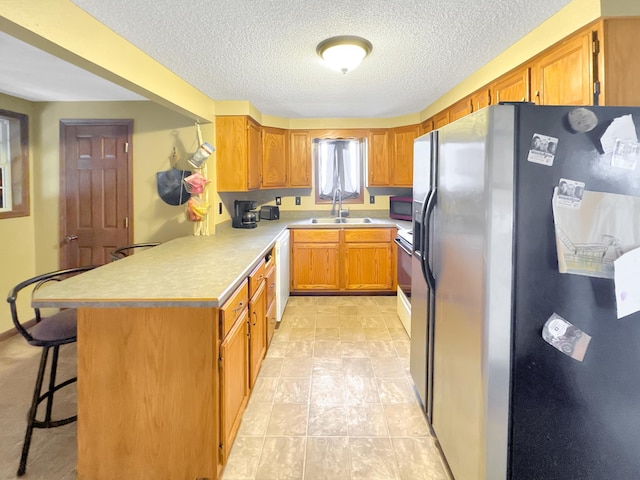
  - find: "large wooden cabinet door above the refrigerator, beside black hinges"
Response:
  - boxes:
[532,29,593,105]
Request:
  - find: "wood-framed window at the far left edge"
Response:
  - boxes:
[0,110,29,219]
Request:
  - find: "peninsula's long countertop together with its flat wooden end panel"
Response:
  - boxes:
[33,222,286,480]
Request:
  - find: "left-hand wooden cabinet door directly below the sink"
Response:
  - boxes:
[291,242,340,291]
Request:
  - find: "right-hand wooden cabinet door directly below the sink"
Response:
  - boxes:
[344,243,393,290]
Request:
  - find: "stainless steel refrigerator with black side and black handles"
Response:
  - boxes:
[411,104,640,480]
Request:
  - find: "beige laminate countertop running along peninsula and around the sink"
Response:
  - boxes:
[33,211,411,307]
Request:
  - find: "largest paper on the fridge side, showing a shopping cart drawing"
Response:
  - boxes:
[552,187,640,278]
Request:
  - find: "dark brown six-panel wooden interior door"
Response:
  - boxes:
[60,120,133,268]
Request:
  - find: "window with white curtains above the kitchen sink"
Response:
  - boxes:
[313,138,366,203]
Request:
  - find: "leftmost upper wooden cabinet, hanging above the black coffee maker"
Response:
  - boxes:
[215,115,262,192]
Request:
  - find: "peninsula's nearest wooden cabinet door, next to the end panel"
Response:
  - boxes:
[219,308,249,463]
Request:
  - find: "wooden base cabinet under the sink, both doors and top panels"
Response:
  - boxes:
[291,228,396,293]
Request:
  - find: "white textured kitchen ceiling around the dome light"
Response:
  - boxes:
[1,0,570,118]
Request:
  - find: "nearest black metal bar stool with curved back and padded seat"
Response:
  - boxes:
[7,266,95,477]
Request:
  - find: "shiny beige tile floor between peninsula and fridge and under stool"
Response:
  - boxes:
[0,297,447,480]
